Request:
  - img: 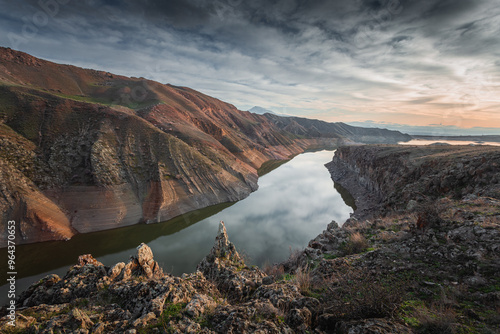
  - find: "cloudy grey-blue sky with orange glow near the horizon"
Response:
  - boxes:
[0,0,500,134]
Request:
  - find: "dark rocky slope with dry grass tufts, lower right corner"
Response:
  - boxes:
[282,196,500,333]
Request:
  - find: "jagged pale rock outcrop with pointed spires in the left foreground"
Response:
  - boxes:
[0,222,318,333]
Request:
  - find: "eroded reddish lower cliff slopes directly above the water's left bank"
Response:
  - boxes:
[0,94,322,246]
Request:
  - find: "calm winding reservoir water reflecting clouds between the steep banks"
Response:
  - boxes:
[0,151,354,305]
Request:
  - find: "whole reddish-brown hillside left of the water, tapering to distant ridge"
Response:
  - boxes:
[0,48,411,247]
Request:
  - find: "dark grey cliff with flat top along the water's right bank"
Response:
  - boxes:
[326,145,500,216]
